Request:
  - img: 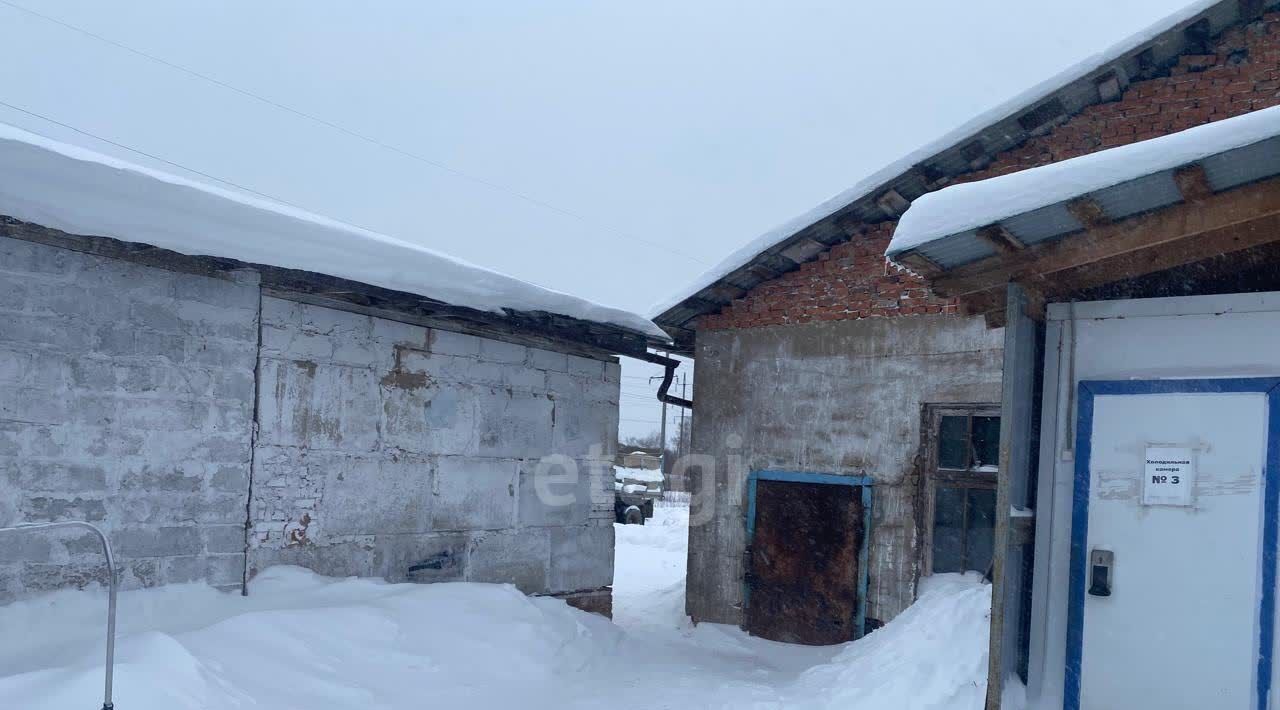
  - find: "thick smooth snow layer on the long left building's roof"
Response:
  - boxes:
[0,124,667,340]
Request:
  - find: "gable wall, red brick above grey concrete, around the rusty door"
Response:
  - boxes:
[687,12,1280,634]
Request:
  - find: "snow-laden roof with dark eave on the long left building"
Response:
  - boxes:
[0,124,667,357]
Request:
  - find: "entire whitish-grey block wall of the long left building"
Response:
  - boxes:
[0,232,620,610]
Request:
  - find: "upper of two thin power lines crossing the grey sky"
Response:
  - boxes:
[0,0,709,266]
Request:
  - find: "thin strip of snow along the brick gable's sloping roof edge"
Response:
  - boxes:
[650,0,1254,345]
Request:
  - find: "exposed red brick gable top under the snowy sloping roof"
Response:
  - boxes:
[698,13,1280,330]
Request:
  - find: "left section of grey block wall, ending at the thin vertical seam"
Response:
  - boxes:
[0,238,259,601]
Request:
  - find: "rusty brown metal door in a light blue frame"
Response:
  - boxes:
[745,472,870,646]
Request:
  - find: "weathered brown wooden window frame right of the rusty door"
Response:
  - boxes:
[920,402,1000,576]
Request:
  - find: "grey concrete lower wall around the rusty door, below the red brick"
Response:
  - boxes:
[687,315,1004,624]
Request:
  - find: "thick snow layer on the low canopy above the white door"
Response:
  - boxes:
[887,106,1280,262]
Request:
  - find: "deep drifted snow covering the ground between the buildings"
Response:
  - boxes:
[0,507,989,710]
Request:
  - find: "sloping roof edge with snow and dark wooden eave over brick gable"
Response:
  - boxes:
[652,0,1280,356]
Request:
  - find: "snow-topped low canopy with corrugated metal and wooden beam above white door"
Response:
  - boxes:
[887,106,1280,325]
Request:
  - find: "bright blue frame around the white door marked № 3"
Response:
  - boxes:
[1064,377,1280,710]
